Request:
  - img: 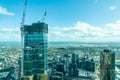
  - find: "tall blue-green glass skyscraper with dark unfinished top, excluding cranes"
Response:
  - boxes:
[21,22,48,80]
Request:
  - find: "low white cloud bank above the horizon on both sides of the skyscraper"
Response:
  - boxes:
[0,20,120,41]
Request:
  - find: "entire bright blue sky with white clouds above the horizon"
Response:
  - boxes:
[0,0,120,42]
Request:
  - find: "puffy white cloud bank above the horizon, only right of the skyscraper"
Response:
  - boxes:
[49,20,120,41]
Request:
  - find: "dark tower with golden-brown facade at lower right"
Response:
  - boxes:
[100,49,115,80]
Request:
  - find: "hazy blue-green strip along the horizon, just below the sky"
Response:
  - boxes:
[0,41,120,48]
